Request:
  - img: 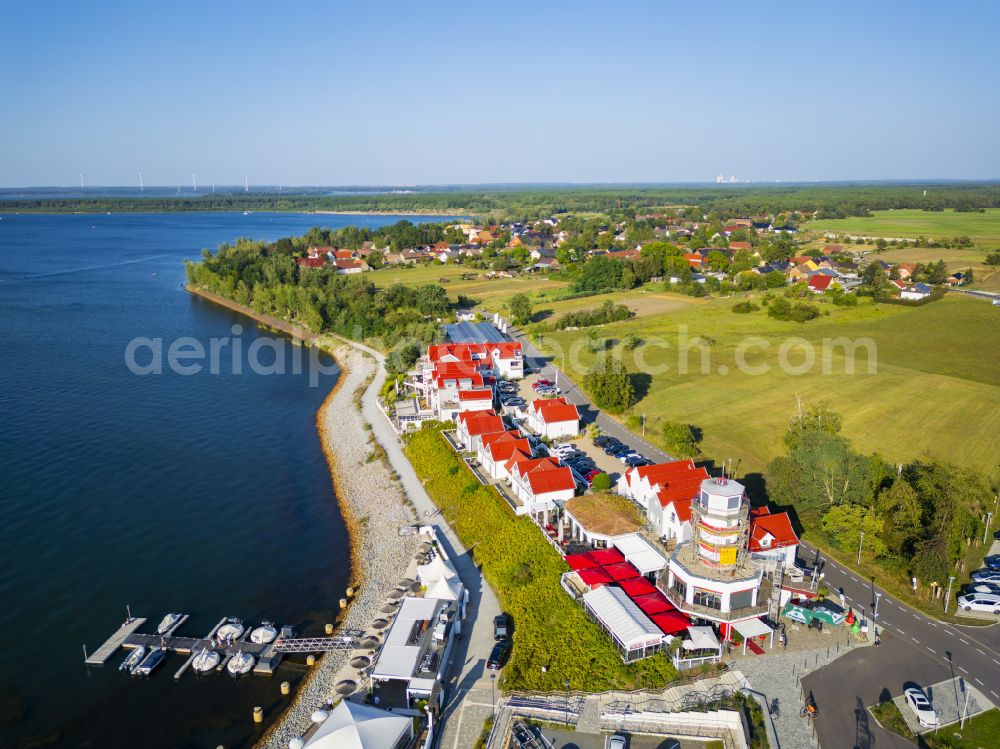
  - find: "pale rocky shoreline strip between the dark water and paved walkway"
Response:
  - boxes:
[258,345,417,749]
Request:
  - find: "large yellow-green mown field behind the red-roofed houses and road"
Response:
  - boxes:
[543,294,1000,481]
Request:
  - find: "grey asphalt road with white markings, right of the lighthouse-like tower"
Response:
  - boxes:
[799,543,1000,704]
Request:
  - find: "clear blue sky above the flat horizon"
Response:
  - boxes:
[0,0,1000,186]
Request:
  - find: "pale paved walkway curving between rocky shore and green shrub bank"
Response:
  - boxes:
[334,340,500,749]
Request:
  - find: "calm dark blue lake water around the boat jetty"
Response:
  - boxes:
[0,206,450,749]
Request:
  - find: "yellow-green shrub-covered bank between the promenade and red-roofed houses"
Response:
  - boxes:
[405,426,677,692]
